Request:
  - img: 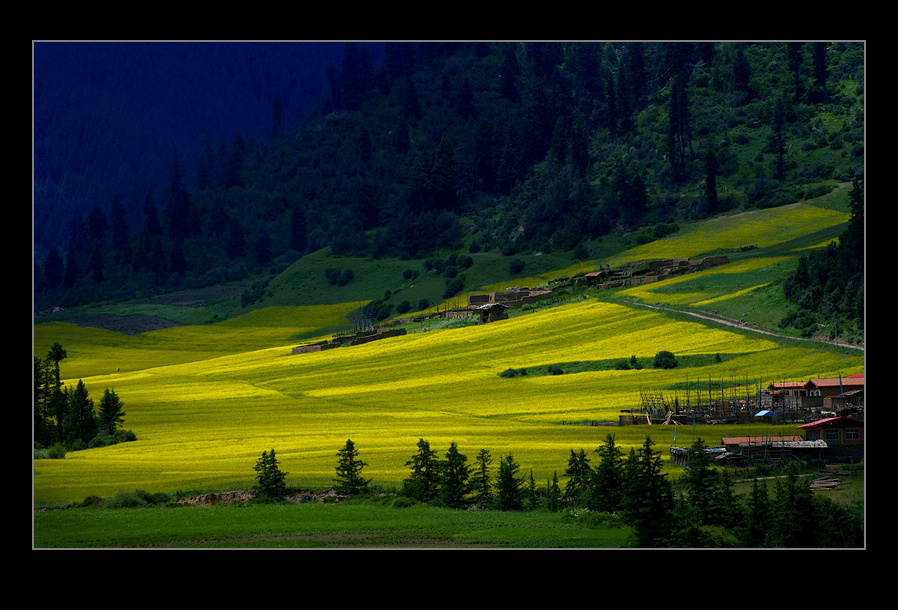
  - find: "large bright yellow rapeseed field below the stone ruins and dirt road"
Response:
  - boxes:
[34,300,863,503]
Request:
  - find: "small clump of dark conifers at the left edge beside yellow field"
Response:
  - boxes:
[32,343,136,458]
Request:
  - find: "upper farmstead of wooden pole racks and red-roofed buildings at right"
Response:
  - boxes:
[620,374,864,426]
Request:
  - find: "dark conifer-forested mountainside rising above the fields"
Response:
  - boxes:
[35,42,864,332]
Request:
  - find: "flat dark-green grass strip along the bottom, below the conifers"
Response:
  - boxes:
[34,502,630,548]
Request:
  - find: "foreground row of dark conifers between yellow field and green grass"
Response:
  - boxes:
[255,434,864,548]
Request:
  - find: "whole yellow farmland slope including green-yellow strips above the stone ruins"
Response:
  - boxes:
[33,195,864,506]
